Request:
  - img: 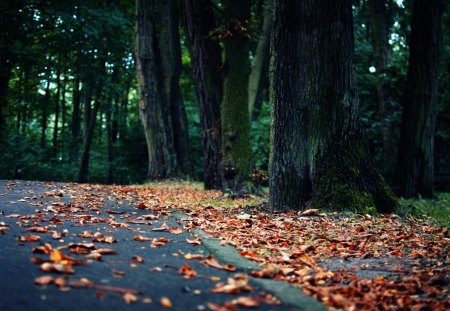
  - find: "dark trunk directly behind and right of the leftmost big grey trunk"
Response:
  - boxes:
[160,0,193,175]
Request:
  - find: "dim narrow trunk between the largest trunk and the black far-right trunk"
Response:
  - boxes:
[367,0,395,172]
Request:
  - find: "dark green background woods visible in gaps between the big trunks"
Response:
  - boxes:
[0,0,450,190]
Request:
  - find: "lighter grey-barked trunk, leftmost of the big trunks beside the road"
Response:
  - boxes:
[136,0,172,179]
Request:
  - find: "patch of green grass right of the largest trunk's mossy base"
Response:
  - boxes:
[397,192,450,228]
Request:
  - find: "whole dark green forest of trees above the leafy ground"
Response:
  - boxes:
[0,0,450,211]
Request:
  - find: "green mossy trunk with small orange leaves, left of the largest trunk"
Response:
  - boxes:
[221,0,251,191]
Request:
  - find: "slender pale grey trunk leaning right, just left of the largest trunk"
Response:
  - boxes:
[248,0,272,121]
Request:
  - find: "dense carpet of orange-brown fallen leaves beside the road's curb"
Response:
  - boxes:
[124,186,450,310]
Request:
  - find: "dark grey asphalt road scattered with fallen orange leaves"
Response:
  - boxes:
[0,181,316,311]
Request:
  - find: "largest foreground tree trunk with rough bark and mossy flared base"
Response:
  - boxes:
[270,0,395,212]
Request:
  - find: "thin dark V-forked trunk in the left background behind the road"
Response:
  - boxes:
[77,85,102,183]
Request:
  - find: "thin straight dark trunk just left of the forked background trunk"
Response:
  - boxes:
[69,74,81,163]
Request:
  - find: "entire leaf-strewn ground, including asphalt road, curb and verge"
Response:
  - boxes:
[0,181,450,310]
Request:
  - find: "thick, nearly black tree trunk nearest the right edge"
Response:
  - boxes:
[395,0,443,197]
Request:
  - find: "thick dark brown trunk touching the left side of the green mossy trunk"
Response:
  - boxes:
[183,0,223,189]
